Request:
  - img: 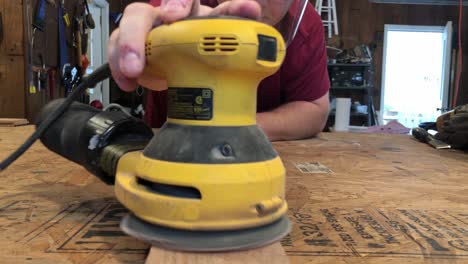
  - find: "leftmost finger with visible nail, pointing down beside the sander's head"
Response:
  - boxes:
[116,3,159,78]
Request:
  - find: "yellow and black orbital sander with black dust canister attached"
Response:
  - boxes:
[0,17,290,251]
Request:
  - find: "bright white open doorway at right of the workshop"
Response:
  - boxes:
[380,22,452,128]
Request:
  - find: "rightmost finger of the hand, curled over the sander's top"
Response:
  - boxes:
[211,0,262,20]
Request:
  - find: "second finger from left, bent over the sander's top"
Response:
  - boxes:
[160,0,200,23]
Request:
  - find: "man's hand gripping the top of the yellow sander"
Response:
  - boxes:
[108,0,261,91]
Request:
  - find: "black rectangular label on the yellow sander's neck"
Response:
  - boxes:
[167,87,213,120]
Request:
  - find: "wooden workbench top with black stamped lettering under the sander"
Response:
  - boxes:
[0,126,468,264]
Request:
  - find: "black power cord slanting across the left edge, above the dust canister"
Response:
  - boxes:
[0,63,111,171]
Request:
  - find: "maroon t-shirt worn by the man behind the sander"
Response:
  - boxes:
[144,0,330,127]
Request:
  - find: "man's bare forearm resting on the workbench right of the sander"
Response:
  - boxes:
[257,96,328,141]
